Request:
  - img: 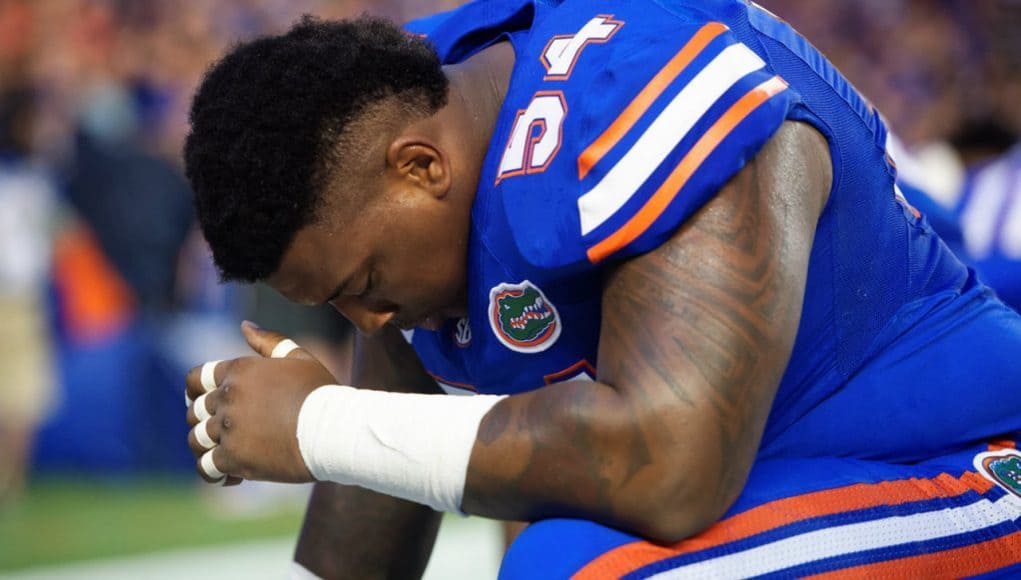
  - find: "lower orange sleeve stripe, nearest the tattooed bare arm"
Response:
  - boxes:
[587,77,787,263]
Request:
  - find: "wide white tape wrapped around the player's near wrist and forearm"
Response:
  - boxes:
[298,385,503,513]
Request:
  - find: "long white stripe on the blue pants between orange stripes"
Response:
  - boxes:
[650,493,1021,580]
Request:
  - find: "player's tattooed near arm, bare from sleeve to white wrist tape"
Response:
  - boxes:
[463,123,832,541]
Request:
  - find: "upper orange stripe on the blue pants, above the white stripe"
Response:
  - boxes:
[573,472,994,580]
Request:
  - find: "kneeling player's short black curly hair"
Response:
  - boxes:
[184,15,447,282]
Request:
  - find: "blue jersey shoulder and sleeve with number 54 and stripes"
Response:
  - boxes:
[490,2,799,272]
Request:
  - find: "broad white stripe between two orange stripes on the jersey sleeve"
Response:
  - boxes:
[578,44,766,236]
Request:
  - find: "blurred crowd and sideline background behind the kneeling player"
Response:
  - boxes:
[0,0,1021,501]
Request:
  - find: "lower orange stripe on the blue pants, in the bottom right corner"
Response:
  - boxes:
[809,532,1021,580]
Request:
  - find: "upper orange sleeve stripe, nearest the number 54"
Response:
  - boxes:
[578,22,728,180]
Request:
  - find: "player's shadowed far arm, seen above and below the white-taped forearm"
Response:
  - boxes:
[294,329,440,578]
